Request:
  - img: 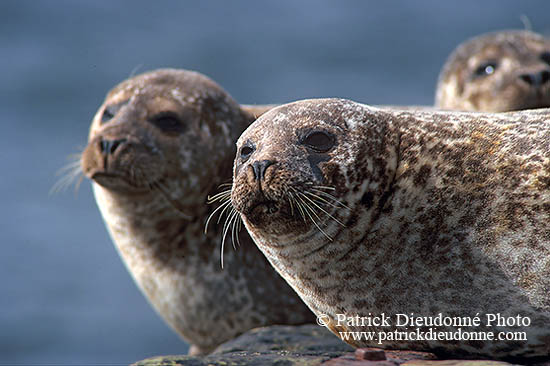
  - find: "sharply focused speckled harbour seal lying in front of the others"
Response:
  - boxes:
[231,99,550,359]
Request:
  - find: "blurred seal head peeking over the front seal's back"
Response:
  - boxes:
[435,31,550,112]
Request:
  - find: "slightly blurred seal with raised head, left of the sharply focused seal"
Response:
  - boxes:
[81,69,315,354]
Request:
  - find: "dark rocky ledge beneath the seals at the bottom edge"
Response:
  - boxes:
[134,325,550,366]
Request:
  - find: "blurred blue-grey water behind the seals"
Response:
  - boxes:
[0,0,550,364]
